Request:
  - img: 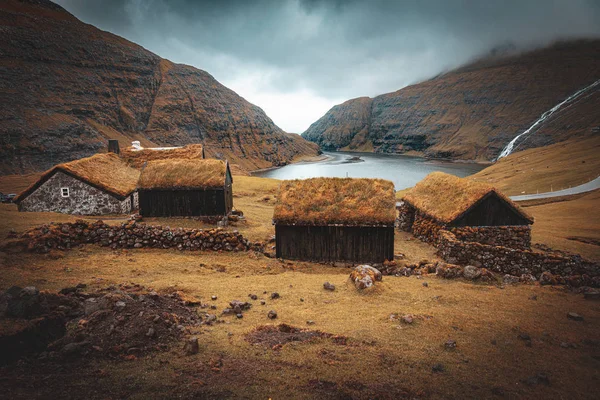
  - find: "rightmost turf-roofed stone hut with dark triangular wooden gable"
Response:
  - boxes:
[398,172,533,249]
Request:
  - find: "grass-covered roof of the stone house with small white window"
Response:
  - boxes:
[16,153,140,201]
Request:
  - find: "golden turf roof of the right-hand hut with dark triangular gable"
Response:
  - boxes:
[402,172,533,224]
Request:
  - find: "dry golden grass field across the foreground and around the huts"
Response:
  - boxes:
[0,172,600,399]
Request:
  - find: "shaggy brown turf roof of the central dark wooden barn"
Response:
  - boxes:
[273,178,396,226]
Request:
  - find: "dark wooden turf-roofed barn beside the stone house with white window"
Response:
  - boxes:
[138,159,233,217]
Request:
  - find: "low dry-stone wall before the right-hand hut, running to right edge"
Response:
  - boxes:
[436,230,600,279]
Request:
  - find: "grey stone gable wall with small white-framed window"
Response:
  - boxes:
[19,171,132,215]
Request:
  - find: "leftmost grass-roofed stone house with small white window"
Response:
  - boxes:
[15,153,140,215]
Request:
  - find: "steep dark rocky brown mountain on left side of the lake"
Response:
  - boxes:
[0,0,318,174]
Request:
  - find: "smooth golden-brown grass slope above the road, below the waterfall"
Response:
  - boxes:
[470,135,600,196]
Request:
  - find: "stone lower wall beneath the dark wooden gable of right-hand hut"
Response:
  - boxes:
[448,225,531,250]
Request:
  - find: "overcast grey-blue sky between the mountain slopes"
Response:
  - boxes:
[57,0,600,133]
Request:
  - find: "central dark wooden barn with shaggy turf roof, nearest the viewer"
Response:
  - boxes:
[273,178,396,263]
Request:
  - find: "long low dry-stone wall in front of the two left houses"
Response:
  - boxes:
[13,220,262,253]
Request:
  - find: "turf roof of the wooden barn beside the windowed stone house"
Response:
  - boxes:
[138,159,229,189]
